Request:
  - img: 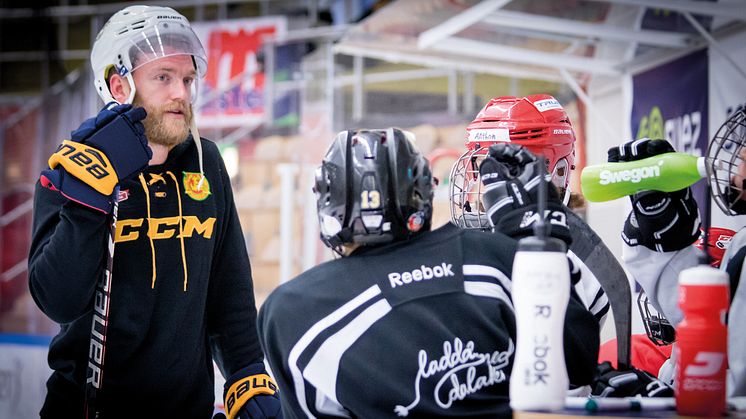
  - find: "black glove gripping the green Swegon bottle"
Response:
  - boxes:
[608,138,700,252]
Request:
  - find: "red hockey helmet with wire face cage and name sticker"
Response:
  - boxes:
[450,94,575,228]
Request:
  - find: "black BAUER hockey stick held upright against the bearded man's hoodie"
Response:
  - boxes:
[85,186,119,419]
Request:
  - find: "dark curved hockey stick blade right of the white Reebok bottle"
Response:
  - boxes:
[567,211,632,370]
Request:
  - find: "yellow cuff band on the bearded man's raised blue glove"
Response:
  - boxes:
[48,140,119,195]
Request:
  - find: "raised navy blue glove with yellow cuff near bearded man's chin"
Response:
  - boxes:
[40,102,153,214]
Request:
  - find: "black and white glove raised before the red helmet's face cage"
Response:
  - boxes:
[479,143,572,247]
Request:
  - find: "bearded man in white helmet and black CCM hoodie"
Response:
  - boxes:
[29,6,280,419]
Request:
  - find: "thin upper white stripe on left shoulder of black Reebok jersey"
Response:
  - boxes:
[288,285,381,418]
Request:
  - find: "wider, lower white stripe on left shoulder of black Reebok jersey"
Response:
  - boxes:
[303,299,391,407]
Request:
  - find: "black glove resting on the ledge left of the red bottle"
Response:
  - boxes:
[591,361,673,397]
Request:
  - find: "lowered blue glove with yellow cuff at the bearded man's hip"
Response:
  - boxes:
[223,362,282,419]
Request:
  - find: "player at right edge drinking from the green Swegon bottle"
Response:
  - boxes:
[609,109,746,396]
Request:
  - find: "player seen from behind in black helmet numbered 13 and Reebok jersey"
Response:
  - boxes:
[258,128,599,418]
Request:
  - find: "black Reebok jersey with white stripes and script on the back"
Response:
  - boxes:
[258,224,599,418]
